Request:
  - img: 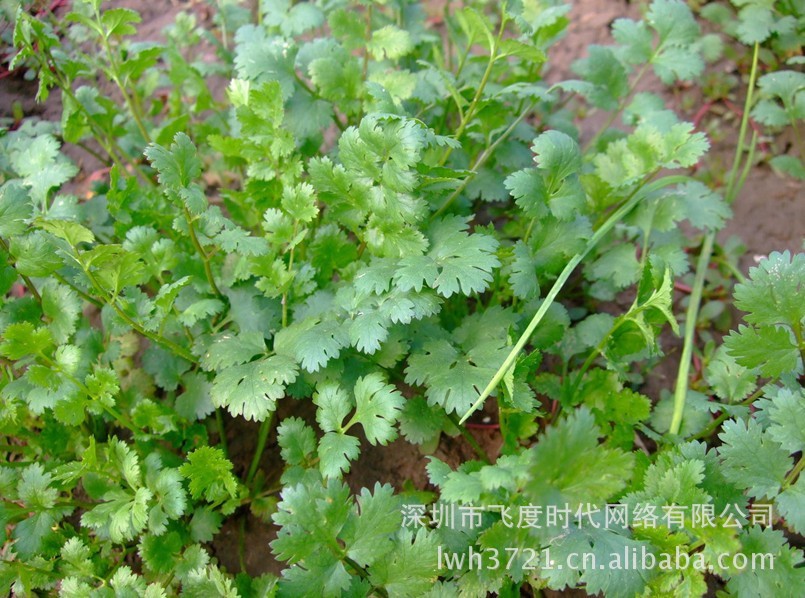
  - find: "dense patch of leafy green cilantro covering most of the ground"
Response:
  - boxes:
[0,0,805,598]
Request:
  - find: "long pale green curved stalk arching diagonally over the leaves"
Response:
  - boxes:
[459,172,690,424]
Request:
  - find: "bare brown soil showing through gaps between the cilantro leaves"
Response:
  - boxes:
[0,0,805,596]
